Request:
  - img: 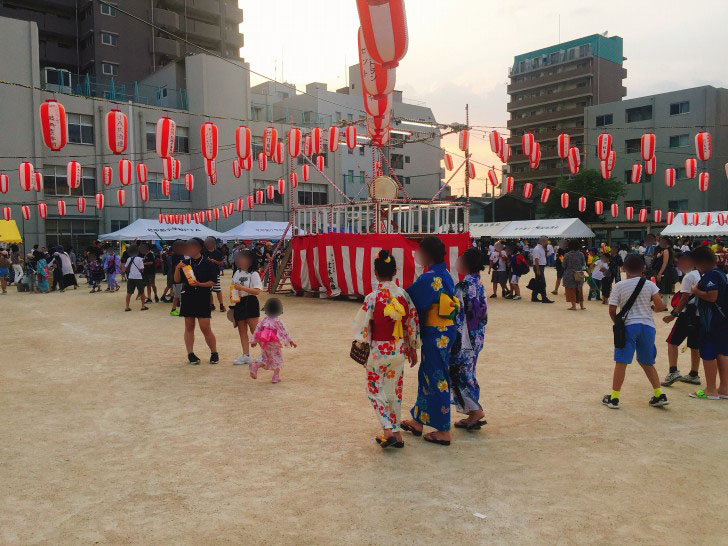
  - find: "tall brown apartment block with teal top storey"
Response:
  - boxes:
[507,34,627,192]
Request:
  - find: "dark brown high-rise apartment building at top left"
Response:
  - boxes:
[0,0,243,88]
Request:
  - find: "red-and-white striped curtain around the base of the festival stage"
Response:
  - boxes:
[291,233,470,297]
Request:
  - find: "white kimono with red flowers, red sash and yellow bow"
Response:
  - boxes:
[354,282,420,432]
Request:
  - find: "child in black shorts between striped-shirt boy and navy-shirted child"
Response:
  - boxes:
[662,252,700,387]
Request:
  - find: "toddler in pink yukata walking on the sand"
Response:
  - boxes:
[250,298,296,383]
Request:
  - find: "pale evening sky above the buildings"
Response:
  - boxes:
[240,0,728,195]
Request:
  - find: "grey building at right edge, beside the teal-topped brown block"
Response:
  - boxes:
[584,86,728,233]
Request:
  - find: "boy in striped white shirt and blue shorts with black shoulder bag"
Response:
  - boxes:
[602,254,668,409]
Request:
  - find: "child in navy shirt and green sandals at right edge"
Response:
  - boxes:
[690,246,728,400]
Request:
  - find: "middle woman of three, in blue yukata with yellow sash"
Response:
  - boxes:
[401,235,460,446]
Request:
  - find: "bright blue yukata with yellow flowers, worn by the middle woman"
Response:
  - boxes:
[407,264,457,431]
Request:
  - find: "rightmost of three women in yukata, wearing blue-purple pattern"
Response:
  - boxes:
[450,248,488,430]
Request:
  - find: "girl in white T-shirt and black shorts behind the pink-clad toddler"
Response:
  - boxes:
[228,250,263,366]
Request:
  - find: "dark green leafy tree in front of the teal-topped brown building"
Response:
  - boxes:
[534,169,625,223]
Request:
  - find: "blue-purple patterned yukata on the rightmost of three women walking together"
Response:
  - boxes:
[450,274,488,414]
